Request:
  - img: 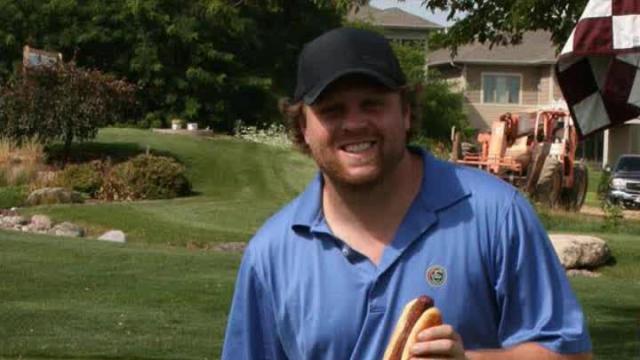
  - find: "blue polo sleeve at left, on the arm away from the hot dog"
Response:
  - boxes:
[222,249,287,360]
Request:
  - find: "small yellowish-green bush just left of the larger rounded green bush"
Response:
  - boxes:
[56,161,104,197]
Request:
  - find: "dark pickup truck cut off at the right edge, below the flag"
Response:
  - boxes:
[609,154,640,209]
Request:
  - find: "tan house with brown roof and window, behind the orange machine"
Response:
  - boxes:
[427,31,640,165]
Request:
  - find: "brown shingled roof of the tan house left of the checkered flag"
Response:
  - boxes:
[427,31,556,66]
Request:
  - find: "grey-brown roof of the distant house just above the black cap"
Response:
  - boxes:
[347,5,443,29]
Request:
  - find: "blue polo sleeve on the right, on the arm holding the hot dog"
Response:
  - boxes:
[495,194,591,353]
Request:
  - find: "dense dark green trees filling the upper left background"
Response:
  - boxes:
[0,0,351,130]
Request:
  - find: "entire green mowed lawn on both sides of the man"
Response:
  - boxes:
[0,129,640,360]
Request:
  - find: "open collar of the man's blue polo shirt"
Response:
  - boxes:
[292,147,469,232]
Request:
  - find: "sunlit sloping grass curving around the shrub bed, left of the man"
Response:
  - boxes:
[24,129,315,245]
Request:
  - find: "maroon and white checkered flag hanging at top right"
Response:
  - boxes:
[556,0,640,137]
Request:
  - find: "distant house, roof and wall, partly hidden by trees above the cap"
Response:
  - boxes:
[347,5,443,49]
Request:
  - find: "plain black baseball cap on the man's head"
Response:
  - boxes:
[293,28,406,105]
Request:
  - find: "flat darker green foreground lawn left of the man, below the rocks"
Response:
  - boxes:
[0,232,240,359]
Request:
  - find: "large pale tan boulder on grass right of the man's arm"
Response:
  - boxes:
[549,234,611,269]
